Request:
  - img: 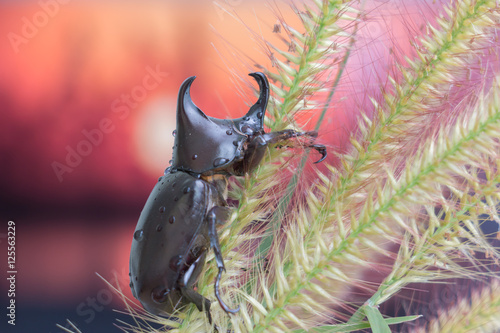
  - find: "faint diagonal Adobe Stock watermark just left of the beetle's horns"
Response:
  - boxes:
[51,65,168,182]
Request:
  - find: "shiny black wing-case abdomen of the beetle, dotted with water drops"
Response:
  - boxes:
[130,172,223,316]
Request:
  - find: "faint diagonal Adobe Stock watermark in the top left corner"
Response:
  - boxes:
[7,0,71,54]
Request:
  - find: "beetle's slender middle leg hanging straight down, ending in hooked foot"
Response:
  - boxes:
[208,206,240,313]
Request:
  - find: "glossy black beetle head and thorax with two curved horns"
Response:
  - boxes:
[172,73,269,174]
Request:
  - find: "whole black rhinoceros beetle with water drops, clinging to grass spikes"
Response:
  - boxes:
[130,72,327,322]
